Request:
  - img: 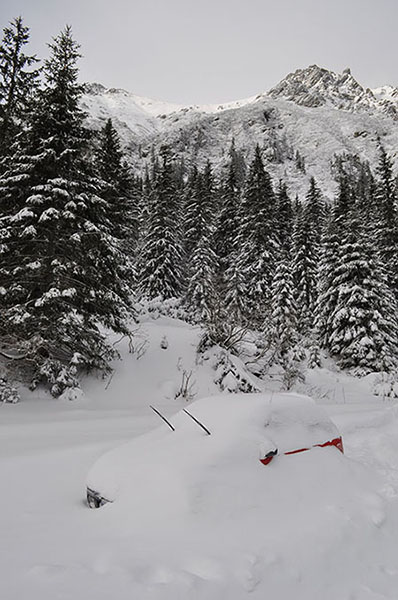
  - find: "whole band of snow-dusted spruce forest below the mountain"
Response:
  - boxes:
[0,18,398,395]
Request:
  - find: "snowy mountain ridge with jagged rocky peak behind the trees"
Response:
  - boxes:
[82,65,398,196]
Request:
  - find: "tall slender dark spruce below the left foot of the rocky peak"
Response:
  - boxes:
[228,146,278,326]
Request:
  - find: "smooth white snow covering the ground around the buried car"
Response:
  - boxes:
[0,317,398,600]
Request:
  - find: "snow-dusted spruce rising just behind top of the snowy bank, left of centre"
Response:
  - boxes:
[138,148,183,299]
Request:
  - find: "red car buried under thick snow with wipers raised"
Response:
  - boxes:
[87,393,342,508]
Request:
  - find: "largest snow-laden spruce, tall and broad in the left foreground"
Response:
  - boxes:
[0,27,129,395]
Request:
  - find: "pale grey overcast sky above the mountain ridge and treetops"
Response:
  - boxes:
[0,0,398,103]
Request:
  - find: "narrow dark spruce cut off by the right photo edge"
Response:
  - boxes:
[374,146,398,298]
